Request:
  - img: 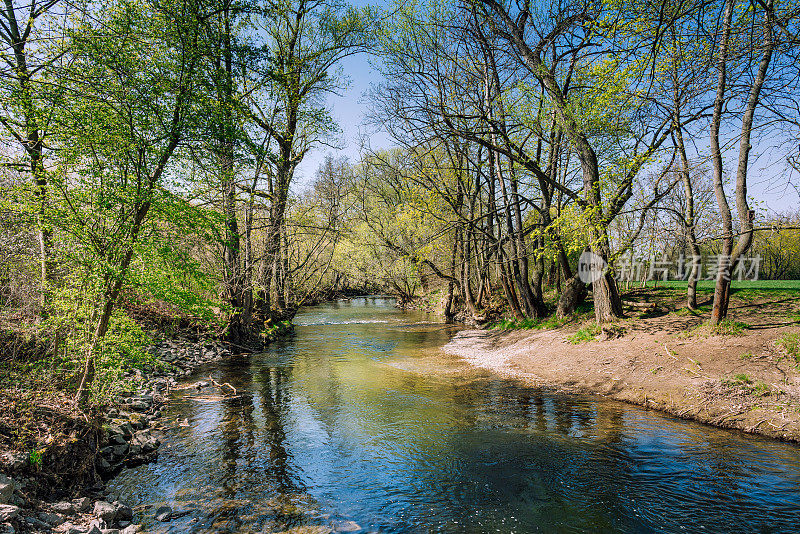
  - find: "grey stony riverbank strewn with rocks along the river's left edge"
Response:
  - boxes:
[0,321,293,534]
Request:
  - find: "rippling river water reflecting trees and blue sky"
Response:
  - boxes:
[112,298,800,533]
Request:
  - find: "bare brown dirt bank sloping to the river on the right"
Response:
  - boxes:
[444,293,800,442]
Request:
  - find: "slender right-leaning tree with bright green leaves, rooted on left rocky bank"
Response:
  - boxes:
[56,0,201,402]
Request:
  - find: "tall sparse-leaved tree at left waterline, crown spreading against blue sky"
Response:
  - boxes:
[243,0,374,316]
